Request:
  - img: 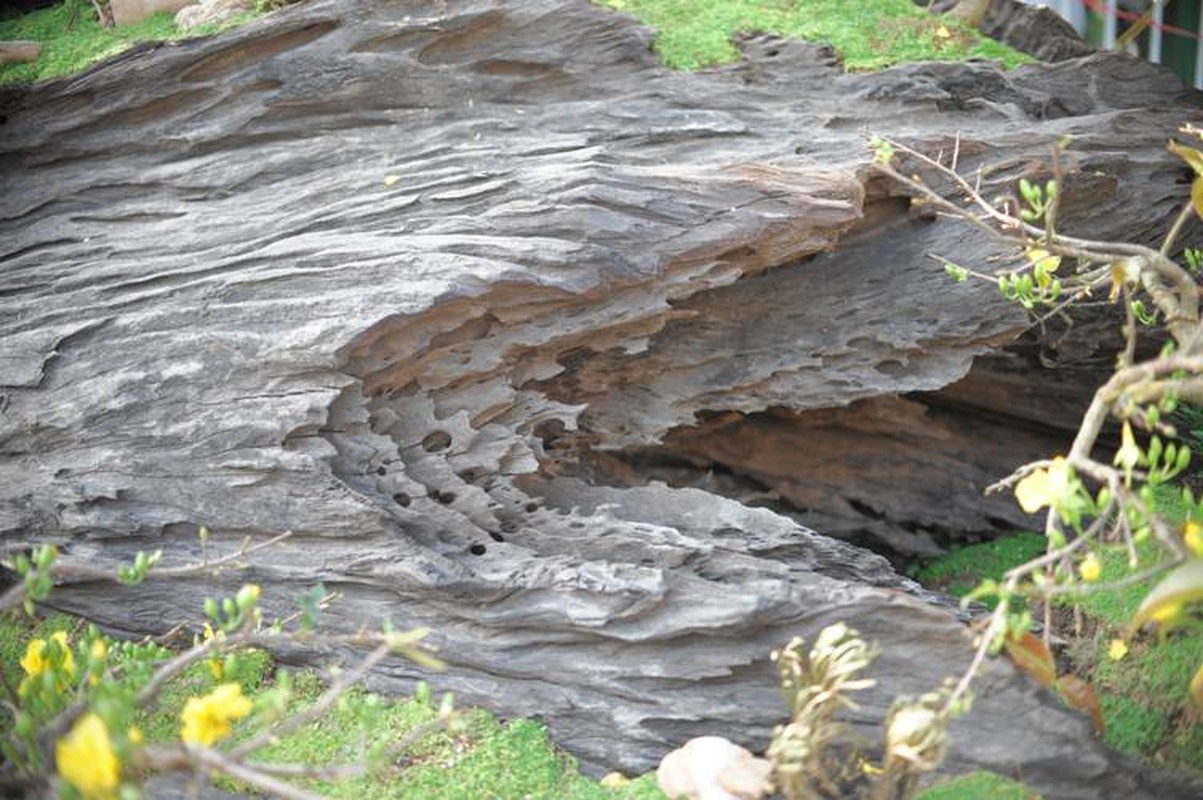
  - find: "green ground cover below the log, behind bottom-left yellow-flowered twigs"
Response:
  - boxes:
[0,614,664,800]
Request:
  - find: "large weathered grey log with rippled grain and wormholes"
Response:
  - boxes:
[0,0,1198,798]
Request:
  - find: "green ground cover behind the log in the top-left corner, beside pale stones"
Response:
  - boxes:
[0,0,256,83]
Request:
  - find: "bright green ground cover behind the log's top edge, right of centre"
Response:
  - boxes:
[598,0,1031,70]
